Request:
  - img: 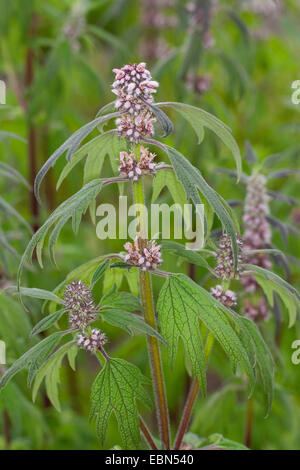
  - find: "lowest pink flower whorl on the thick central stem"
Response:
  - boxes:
[124,238,162,271]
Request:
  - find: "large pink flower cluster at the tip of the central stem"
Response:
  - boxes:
[112,62,158,142]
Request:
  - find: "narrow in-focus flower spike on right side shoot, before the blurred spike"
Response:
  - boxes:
[215,233,243,280]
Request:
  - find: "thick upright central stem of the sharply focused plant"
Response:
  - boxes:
[133,145,170,449]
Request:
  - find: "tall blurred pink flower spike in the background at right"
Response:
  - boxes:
[241,173,272,292]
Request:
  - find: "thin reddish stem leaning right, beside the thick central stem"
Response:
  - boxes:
[174,333,214,450]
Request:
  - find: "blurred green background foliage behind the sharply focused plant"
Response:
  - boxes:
[0,0,300,449]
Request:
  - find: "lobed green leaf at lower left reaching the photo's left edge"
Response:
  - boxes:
[0,331,64,390]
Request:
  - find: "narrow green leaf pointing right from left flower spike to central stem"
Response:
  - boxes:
[100,309,167,344]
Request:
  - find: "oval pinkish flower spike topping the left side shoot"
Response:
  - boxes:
[64,281,97,329]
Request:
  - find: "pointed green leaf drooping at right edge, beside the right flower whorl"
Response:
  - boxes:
[245,264,300,328]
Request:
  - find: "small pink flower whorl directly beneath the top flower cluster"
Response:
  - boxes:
[119,146,156,181]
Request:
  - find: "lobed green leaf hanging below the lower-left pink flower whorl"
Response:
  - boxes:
[32,341,78,411]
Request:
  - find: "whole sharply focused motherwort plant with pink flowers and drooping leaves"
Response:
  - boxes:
[0,63,299,449]
